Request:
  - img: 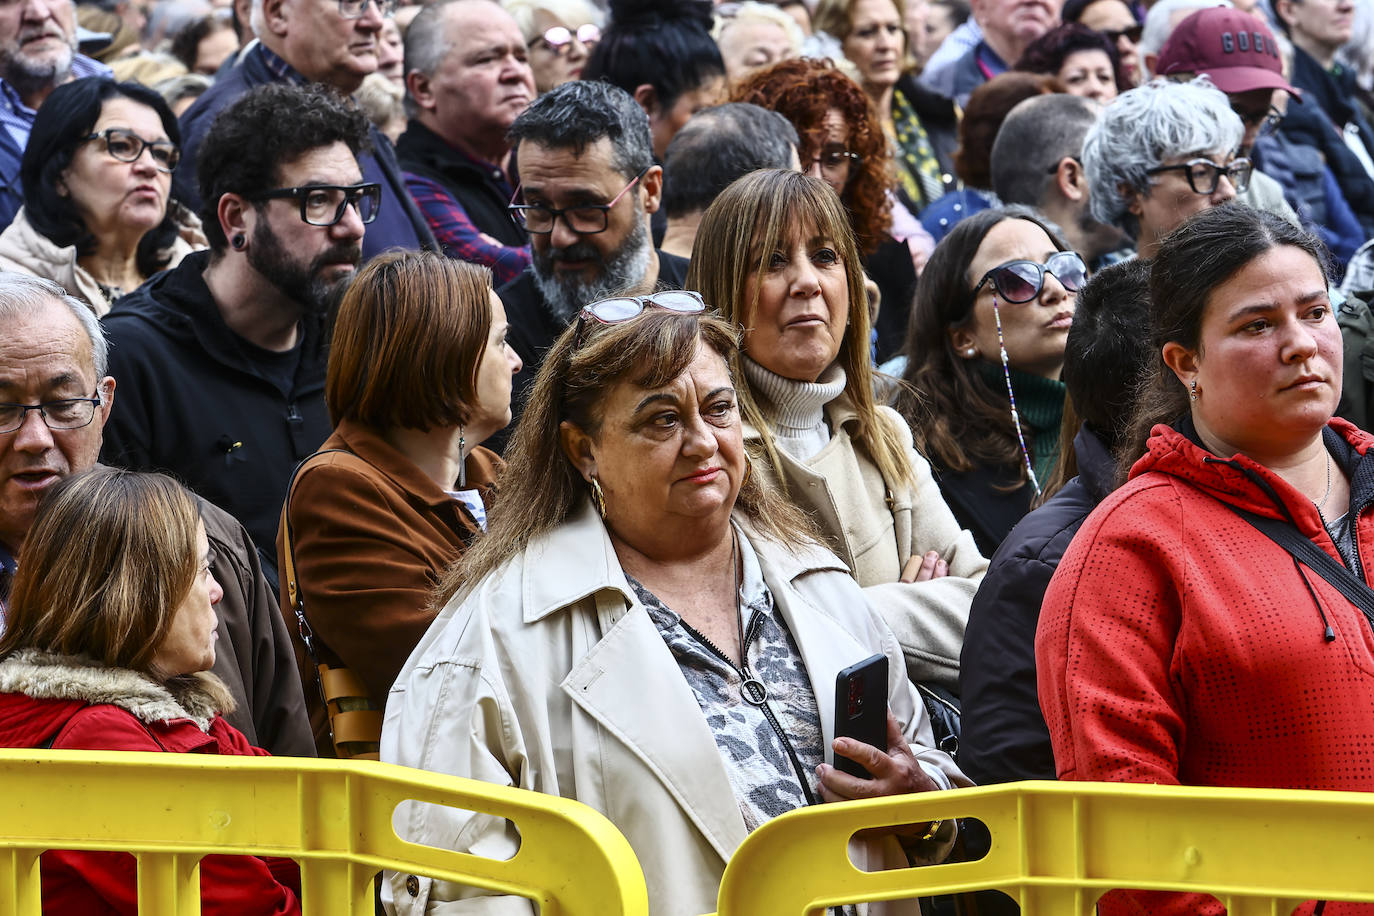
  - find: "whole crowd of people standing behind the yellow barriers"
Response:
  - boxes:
[0,0,1374,916]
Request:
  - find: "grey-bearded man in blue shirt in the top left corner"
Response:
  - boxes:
[0,0,110,229]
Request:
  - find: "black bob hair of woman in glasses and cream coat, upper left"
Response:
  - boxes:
[19,77,181,277]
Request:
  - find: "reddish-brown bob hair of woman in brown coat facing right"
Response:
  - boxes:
[324,251,492,431]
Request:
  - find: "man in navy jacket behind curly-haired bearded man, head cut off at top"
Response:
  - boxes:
[173,0,436,258]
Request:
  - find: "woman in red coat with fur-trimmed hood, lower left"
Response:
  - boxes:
[0,467,301,916]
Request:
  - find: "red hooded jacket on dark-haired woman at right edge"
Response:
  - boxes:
[1036,419,1374,916]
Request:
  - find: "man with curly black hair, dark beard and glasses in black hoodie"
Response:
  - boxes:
[100,84,379,578]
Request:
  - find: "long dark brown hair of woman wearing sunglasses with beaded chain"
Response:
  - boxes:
[897,206,1069,481]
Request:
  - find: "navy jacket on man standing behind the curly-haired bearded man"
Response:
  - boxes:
[172,45,437,261]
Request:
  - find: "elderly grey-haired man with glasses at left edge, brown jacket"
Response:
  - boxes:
[0,272,315,757]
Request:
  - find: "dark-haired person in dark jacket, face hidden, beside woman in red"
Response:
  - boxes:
[959,258,1151,784]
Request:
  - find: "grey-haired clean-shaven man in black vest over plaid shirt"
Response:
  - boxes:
[396,0,534,286]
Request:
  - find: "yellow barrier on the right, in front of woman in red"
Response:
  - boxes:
[719,783,1374,916]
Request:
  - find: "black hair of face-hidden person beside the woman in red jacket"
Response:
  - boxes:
[1062,258,1150,452]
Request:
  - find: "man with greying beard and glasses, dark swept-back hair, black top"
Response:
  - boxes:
[497,80,687,448]
